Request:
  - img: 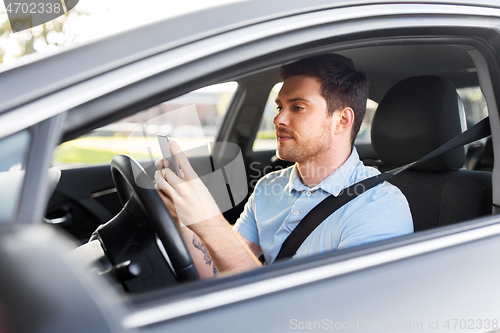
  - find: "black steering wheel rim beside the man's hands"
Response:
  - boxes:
[111,154,199,281]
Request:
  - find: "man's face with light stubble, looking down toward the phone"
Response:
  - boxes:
[273,75,335,163]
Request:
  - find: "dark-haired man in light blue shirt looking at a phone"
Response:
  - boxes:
[155,54,413,276]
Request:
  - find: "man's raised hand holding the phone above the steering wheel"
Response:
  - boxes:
[155,141,221,229]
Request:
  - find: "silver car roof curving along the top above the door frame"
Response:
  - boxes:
[0,0,500,113]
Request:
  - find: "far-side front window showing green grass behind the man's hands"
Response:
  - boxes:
[53,82,238,168]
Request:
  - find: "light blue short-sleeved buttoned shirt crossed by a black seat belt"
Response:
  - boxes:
[234,147,413,263]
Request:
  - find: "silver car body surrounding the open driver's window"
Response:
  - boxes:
[0,0,500,332]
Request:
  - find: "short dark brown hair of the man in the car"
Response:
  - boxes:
[280,53,369,144]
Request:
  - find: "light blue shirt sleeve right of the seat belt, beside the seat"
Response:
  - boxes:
[337,183,413,249]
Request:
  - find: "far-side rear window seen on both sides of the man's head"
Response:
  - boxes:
[253,82,378,151]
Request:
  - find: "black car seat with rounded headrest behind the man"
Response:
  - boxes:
[371,76,492,231]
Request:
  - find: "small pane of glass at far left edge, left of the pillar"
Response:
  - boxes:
[0,130,31,222]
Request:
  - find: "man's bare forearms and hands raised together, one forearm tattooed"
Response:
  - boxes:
[155,141,261,277]
